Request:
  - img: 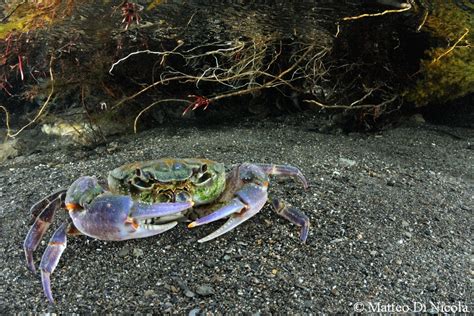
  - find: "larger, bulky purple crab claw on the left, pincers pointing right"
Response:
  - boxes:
[66,194,193,240]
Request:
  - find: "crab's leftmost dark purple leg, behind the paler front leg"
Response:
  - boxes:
[23,190,65,272]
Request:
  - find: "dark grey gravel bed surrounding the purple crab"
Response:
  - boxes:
[0,114,474,315]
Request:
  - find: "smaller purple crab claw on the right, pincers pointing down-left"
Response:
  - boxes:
[188,183,267,243]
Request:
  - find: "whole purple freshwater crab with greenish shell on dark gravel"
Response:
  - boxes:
[24,158,309,303]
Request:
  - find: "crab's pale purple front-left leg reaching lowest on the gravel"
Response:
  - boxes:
[40,222,68,303]
